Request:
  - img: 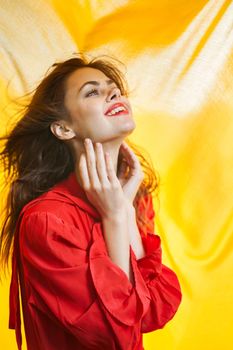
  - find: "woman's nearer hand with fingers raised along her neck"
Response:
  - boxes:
[77,139,126,218]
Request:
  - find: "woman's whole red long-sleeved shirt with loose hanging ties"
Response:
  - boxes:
[9,173,182,350]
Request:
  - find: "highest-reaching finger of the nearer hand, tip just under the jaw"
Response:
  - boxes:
[84,139,100,188]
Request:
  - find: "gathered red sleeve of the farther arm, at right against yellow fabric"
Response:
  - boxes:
[135,195,182,333]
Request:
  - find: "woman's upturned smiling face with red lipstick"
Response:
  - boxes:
[62,67,135,142]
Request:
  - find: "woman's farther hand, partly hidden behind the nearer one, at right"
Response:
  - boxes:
[118,142,144,205]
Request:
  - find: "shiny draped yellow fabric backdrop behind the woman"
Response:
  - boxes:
[0,0,233,350]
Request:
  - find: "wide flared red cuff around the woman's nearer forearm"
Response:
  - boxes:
[89,222,150,326]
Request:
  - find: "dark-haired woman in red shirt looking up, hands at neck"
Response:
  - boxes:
[1,57,181,350]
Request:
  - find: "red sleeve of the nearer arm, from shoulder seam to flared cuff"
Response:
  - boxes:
[20,212,150,349]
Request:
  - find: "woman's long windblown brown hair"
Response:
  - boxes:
[0,55,158,274]
